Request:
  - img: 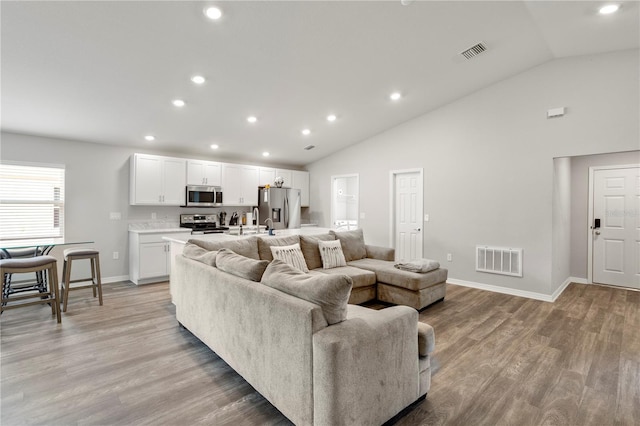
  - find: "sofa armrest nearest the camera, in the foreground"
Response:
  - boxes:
[313,306,419,425]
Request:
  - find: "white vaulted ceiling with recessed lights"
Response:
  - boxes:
[0,0,640,165]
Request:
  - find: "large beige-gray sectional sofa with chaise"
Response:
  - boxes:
[171,231,446,425]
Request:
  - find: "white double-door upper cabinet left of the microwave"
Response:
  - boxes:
[129,154,187,206]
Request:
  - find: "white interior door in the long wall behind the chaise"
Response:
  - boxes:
[394,171,423,261]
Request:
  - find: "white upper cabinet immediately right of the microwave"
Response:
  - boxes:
[222,164,259,206]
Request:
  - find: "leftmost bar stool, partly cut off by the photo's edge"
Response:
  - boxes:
[0,256,61,322]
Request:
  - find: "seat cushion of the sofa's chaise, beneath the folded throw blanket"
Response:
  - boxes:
[349,259,448,291]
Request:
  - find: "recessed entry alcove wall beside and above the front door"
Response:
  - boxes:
[571,151,640,280]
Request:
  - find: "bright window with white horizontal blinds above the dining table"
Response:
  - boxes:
[0,163,64,241]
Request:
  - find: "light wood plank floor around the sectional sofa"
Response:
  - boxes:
[0,283,640,426]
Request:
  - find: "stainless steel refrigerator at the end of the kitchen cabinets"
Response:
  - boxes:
[258,186,301,229]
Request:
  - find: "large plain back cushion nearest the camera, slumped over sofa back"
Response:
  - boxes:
[262,259,352,325]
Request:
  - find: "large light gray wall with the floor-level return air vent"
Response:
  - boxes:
[307,50,640,295]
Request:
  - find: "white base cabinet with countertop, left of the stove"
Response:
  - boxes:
[129,230,191,285]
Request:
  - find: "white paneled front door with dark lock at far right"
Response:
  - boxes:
[591,167,640,288]
